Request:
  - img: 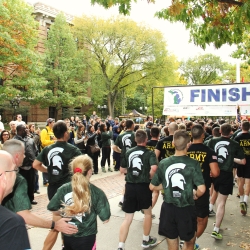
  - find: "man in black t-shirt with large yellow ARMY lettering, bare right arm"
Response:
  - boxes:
[187,124,220,248]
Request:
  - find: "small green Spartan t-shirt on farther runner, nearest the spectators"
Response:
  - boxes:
[115,131,136,159]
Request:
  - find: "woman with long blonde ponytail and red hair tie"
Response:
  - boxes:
[48,155,111,250]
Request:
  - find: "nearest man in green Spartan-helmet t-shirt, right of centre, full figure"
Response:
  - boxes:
[150,130,206,250]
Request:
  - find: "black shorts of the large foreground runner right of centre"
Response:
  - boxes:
[158,202,197,241]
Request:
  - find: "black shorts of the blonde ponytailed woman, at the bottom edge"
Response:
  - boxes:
[63,234,96,250]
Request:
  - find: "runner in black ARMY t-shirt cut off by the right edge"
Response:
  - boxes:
[235,121,250,215]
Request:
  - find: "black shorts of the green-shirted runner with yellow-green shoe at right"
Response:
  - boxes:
[214,171,233,195]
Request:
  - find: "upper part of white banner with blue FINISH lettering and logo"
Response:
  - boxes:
[164,83,250,109]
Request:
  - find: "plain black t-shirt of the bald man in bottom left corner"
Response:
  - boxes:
[0,205,31,250]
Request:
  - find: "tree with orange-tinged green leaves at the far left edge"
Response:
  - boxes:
[0,0,45,102]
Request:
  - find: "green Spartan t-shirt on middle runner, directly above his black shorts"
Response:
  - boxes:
[121,146,157,183]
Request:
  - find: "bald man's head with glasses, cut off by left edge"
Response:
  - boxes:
[0,150,16,199]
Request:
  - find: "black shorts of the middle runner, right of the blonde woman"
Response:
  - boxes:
[122,182,152,213]
